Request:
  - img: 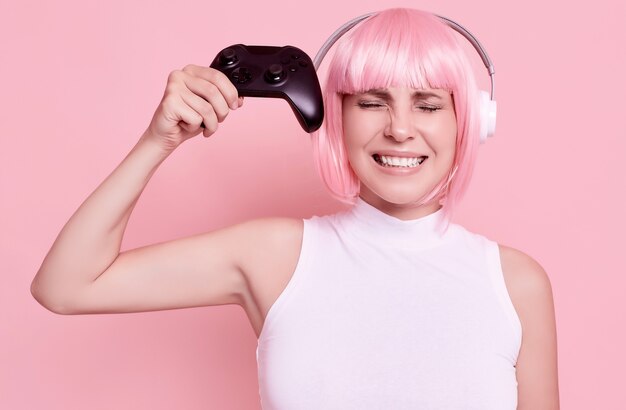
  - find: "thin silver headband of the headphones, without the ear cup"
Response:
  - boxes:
[313,12,496,101]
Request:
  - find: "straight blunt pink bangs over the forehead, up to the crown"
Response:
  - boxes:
[327,10,463,94]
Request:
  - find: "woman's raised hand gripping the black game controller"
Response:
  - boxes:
[142,64,243,151]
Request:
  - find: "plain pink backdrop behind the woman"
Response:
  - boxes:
[0,0,626,410]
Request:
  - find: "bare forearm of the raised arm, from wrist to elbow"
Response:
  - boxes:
[31,134,169,308]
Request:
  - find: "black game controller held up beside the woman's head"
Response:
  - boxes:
[211,44,324,133]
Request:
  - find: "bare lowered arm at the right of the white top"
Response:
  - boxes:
[499,245,559,409]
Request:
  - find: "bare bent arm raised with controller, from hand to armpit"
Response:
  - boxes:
[31,65,258,314]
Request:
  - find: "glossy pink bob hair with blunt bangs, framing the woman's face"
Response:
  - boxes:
[312,8,480,229]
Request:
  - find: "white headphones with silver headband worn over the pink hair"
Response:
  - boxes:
[313,13,497,144]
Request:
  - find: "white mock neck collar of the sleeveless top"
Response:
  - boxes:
[348,198,445,249]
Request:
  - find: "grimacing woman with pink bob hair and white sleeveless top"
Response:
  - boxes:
[32,9,559,410]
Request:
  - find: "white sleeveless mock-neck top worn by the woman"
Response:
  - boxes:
[257,199,522,410]
